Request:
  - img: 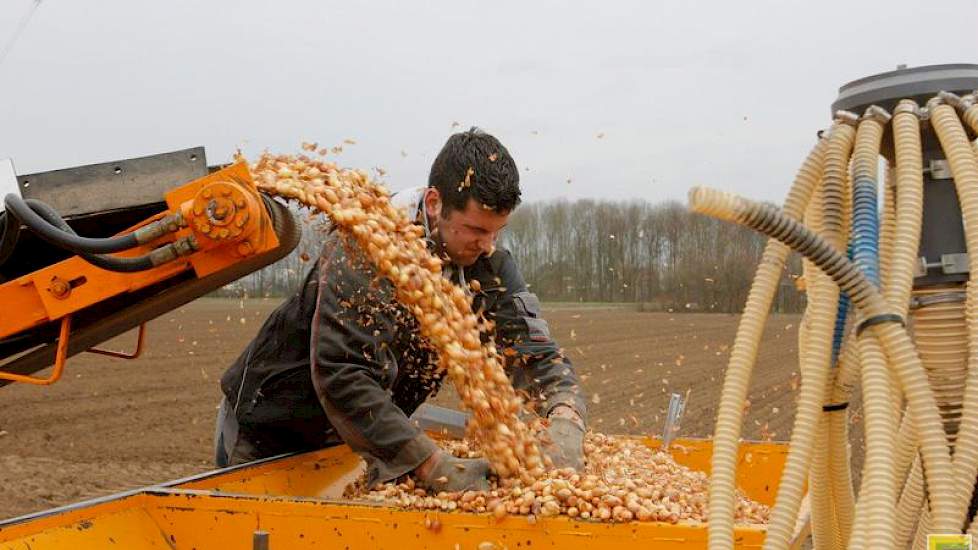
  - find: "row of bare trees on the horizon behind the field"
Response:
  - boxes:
[221,199,804,313]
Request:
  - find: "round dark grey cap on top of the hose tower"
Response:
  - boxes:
[832,63,978,114]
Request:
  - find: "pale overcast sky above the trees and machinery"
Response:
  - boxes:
[0,0,978,202]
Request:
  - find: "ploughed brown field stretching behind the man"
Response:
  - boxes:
[0,298,799,518]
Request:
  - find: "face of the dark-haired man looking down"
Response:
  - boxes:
[424,187,509,267]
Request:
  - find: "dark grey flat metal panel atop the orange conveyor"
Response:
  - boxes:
[17,147,207,218]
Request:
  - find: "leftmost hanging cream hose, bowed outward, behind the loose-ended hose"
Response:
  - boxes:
[707,132,839,550]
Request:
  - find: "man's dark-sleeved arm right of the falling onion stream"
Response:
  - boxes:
[494,249,587,422]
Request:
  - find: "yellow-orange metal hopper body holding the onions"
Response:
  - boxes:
[0,438,787,550]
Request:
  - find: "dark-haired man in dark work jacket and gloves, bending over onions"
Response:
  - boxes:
[217,128,585,491]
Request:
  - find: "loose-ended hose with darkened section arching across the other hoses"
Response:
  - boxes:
[690,188,963,538]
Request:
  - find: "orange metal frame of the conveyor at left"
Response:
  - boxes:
[0,163,279,385]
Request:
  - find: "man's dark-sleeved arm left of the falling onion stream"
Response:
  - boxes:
[310,234,438,483]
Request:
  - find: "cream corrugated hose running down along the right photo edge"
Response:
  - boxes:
[925,102,978,523]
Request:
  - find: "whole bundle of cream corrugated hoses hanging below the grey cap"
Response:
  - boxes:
[690,93,978,550]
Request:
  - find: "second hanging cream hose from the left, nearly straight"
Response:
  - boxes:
[764,117,855,550]
